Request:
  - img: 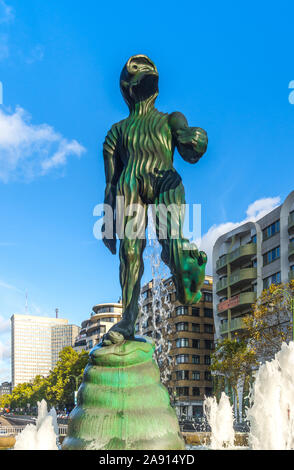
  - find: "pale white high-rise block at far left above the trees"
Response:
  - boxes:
[11,314,78,388]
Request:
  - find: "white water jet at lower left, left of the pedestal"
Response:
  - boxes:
[14,400,58,450]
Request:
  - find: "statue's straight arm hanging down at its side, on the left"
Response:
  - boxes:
[103,125,123,254]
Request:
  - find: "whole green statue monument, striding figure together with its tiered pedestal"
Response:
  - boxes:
[62,54,208,450]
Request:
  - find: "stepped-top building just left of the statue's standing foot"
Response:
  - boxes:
[74,303,122,351]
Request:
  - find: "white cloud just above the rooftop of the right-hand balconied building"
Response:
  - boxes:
[196,197,280,274]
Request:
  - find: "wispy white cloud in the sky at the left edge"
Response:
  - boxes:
[0,107,85,182]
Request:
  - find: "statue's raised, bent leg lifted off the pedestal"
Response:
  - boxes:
[153,170,207,304]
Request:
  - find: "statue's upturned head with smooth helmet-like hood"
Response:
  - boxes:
[120,54,158,108]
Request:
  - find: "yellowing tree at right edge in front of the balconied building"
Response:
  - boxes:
[244,281,294,362]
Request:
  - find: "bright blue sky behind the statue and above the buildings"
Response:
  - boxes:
[0,0,294,381]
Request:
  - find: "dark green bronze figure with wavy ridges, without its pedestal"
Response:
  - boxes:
[103,54,208,345]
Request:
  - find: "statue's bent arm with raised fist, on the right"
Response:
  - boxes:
[169,112,208,163]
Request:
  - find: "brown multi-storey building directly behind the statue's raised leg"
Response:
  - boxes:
[137,276,214,419]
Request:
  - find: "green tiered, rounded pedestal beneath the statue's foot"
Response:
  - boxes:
[62,338,185,450]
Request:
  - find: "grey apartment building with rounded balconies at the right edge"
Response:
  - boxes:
[213,191,294,339]
